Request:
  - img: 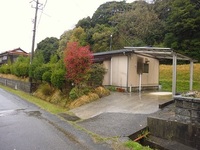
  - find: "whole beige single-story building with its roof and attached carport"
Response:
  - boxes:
[94,47,197,94]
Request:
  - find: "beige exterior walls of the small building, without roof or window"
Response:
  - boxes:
[103,54,159,87]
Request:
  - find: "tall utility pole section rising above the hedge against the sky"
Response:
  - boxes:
[30,0,39,64]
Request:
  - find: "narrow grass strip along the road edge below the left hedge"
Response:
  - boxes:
[0,85,67,114]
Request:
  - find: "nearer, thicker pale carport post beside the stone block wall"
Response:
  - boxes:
[172,53,177,96]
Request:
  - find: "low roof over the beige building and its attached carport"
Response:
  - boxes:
[94,47,196,62]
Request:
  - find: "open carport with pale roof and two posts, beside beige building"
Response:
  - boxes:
[125,47,197,95]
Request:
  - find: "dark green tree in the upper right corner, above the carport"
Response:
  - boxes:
[165,0,200,59]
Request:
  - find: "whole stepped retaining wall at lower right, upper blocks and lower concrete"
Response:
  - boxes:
[147,97,200,150]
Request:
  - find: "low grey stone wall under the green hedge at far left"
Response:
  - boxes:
[0,78,31,93]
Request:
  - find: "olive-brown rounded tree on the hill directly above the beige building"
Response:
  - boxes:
[113,1,163,46]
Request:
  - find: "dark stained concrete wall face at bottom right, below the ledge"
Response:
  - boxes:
[147,117,200,149]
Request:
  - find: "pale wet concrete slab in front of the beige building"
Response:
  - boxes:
[70,92,172,119]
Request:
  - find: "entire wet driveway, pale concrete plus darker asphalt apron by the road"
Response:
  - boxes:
[70,92,172,139]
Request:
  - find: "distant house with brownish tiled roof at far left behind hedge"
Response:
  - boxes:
[0,48,29,65]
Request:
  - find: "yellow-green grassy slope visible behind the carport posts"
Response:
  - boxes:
[159,63,200,92]
